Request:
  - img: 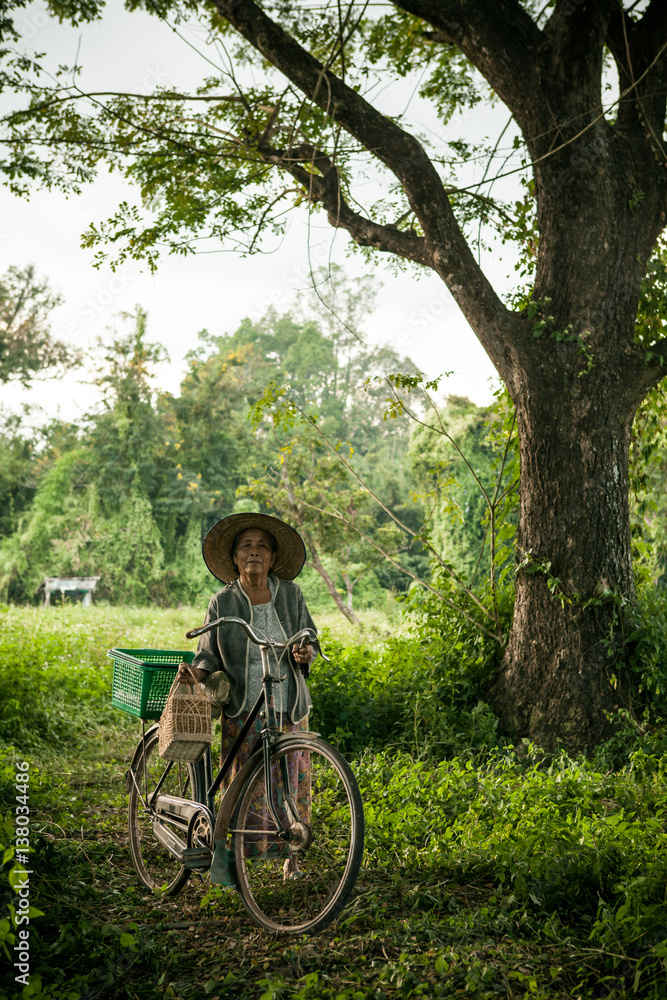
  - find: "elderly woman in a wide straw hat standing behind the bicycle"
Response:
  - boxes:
[178,514,316,884]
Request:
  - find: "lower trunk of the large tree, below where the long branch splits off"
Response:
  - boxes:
[491,360,635,750]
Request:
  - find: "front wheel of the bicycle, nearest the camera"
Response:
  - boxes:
[230,736,364,934]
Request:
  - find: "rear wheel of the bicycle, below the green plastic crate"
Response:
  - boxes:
[128,727,203,895]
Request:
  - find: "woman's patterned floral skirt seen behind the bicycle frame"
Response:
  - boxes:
[220,712,311,857]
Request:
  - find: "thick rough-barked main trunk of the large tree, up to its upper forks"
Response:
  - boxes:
[490,76,664,751]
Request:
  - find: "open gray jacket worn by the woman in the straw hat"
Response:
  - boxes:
[193,577,317,722]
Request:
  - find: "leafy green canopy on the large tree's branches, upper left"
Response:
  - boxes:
[2,2,501,267]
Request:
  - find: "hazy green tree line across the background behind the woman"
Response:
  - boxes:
[0,267,667,622]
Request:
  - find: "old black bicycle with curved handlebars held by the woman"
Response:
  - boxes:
[126,617,364,934]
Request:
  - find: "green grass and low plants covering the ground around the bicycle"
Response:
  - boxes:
[0,608,667,1000]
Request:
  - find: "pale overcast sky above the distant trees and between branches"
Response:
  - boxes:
[0,0,512,419]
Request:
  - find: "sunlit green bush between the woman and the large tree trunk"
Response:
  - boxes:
[310,590,510,756]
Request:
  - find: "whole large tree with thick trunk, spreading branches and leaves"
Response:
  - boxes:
[2,0,667,747]
